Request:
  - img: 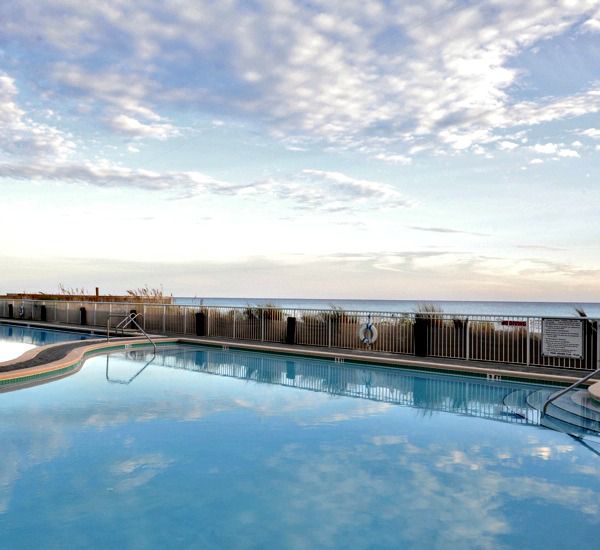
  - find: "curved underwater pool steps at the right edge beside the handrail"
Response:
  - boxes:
[527,389,600,437]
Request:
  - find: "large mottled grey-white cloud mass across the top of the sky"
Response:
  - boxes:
[0,0,600,155]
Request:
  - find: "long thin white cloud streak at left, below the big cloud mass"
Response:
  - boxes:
[0,68,414,212]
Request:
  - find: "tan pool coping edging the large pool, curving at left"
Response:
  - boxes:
[0,329,600,398]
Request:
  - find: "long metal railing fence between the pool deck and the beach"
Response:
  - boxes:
[0,300,600,371]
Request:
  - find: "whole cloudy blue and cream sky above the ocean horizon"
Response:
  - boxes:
[0,0,600,302]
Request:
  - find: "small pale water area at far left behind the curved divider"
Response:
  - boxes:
[0,323,98,362]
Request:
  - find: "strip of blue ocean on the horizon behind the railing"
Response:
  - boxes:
[175,296,600,318]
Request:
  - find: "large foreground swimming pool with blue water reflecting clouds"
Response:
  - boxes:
[0,346,600,548]
